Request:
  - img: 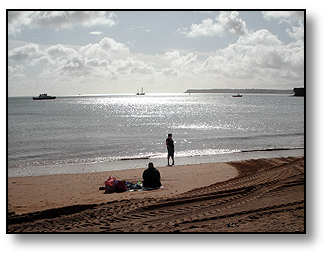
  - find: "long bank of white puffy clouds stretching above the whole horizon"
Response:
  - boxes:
[9,30,304,92]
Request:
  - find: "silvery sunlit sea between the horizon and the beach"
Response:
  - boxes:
[7,94,305,177]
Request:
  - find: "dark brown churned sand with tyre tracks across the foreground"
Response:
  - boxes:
[8,157,304,233]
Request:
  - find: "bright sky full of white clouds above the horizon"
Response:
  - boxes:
[8,11,304,96]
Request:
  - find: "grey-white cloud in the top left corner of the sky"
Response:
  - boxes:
[8,11,117,35]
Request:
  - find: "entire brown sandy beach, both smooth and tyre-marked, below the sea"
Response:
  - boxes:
[7,157,305,233]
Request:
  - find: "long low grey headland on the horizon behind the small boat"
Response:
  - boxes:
[184,88,295,95]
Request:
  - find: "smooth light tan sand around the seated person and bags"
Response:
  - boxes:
[8,163,238,214]
